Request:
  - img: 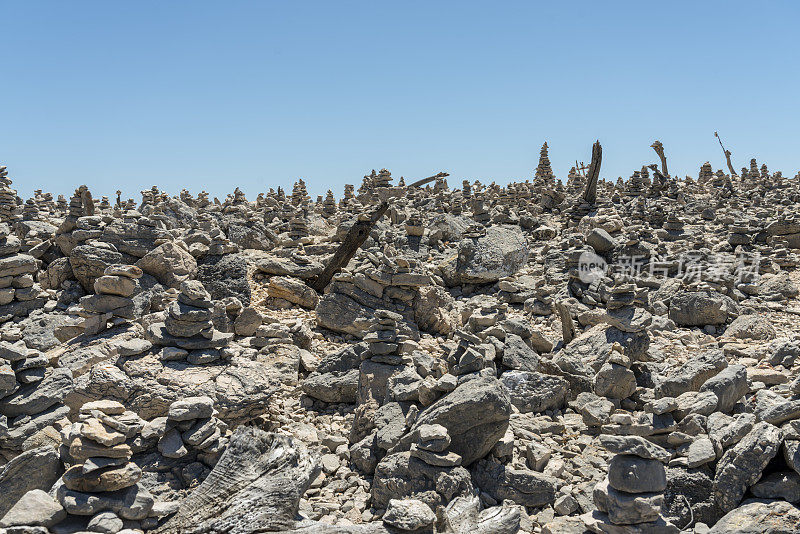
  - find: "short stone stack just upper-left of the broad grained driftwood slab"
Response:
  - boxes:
[154,397,228,467]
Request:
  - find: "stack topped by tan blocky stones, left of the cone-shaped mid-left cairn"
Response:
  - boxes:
[80,264,144,335]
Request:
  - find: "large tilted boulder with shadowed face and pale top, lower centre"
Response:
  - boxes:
[409,377,511,465]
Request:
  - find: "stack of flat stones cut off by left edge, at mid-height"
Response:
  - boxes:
[0,223,42,317]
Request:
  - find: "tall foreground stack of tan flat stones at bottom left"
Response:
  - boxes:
[56,400,154,528]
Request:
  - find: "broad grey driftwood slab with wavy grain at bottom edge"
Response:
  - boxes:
[156,426,320,534]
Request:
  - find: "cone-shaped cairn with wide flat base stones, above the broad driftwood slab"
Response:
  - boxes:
[148,280,234,356]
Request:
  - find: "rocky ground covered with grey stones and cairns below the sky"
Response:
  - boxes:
[0,151,800,534]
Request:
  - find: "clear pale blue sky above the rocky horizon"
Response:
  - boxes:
[0,0,800,201]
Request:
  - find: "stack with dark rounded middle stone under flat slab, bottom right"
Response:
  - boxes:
[582,434,680,534]
